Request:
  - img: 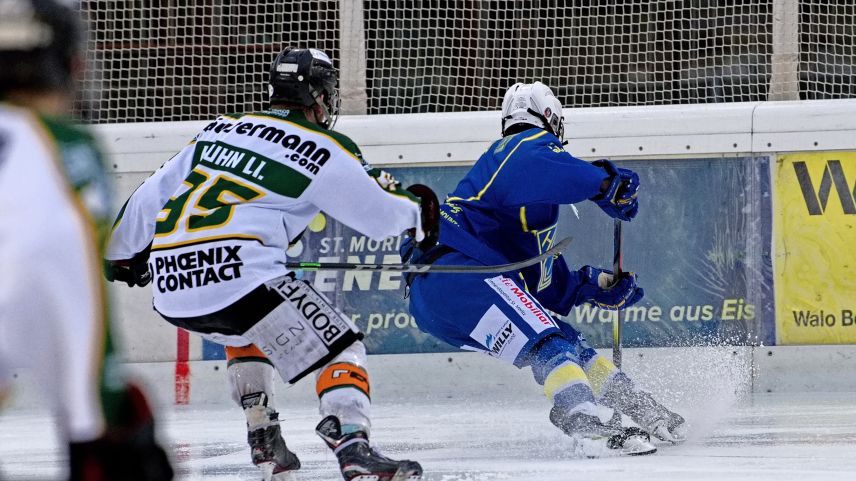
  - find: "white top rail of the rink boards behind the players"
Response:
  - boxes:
[94,99,856,174]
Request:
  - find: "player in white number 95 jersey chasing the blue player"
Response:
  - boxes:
[107,48,436,481]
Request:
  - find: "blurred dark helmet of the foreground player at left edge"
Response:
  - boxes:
[0,0,83,97]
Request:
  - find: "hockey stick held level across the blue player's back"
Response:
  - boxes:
[285,237,571,274]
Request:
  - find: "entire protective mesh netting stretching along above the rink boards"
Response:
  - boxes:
[78,0,856,123]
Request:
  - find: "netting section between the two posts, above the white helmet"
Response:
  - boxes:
[366,0,772,113]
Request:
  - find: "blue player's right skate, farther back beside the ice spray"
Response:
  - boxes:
[604,390,687,444]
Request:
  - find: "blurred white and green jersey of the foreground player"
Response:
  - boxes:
[0,103,124,441]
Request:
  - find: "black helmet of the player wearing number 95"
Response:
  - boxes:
[268,47,339,129]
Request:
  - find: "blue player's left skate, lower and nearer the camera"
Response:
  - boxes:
[550,403,657,458]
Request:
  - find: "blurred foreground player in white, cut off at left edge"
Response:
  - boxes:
[0,0,173,481]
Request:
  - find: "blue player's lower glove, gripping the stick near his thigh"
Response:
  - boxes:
[574,266,645,311]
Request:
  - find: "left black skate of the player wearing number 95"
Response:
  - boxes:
[241,393,300,481]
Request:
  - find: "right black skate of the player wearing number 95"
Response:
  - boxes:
[315,416,422,481]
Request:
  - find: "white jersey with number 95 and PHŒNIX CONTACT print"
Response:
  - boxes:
[107,110,422,317]
